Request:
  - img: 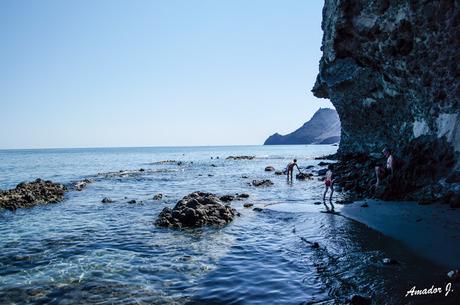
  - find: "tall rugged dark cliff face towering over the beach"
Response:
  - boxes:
[312,0,460,167]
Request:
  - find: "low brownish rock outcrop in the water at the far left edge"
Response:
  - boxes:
[0,179,67,210]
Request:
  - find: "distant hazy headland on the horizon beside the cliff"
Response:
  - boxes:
[264,108,340,145]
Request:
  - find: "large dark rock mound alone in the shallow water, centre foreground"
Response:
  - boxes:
[155,192,238,228]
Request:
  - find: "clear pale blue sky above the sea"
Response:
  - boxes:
[0,0,332,148]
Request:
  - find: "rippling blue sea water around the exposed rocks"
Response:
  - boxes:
[0,145,454,304]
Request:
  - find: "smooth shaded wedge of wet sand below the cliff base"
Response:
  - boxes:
[338,199,460,273]
